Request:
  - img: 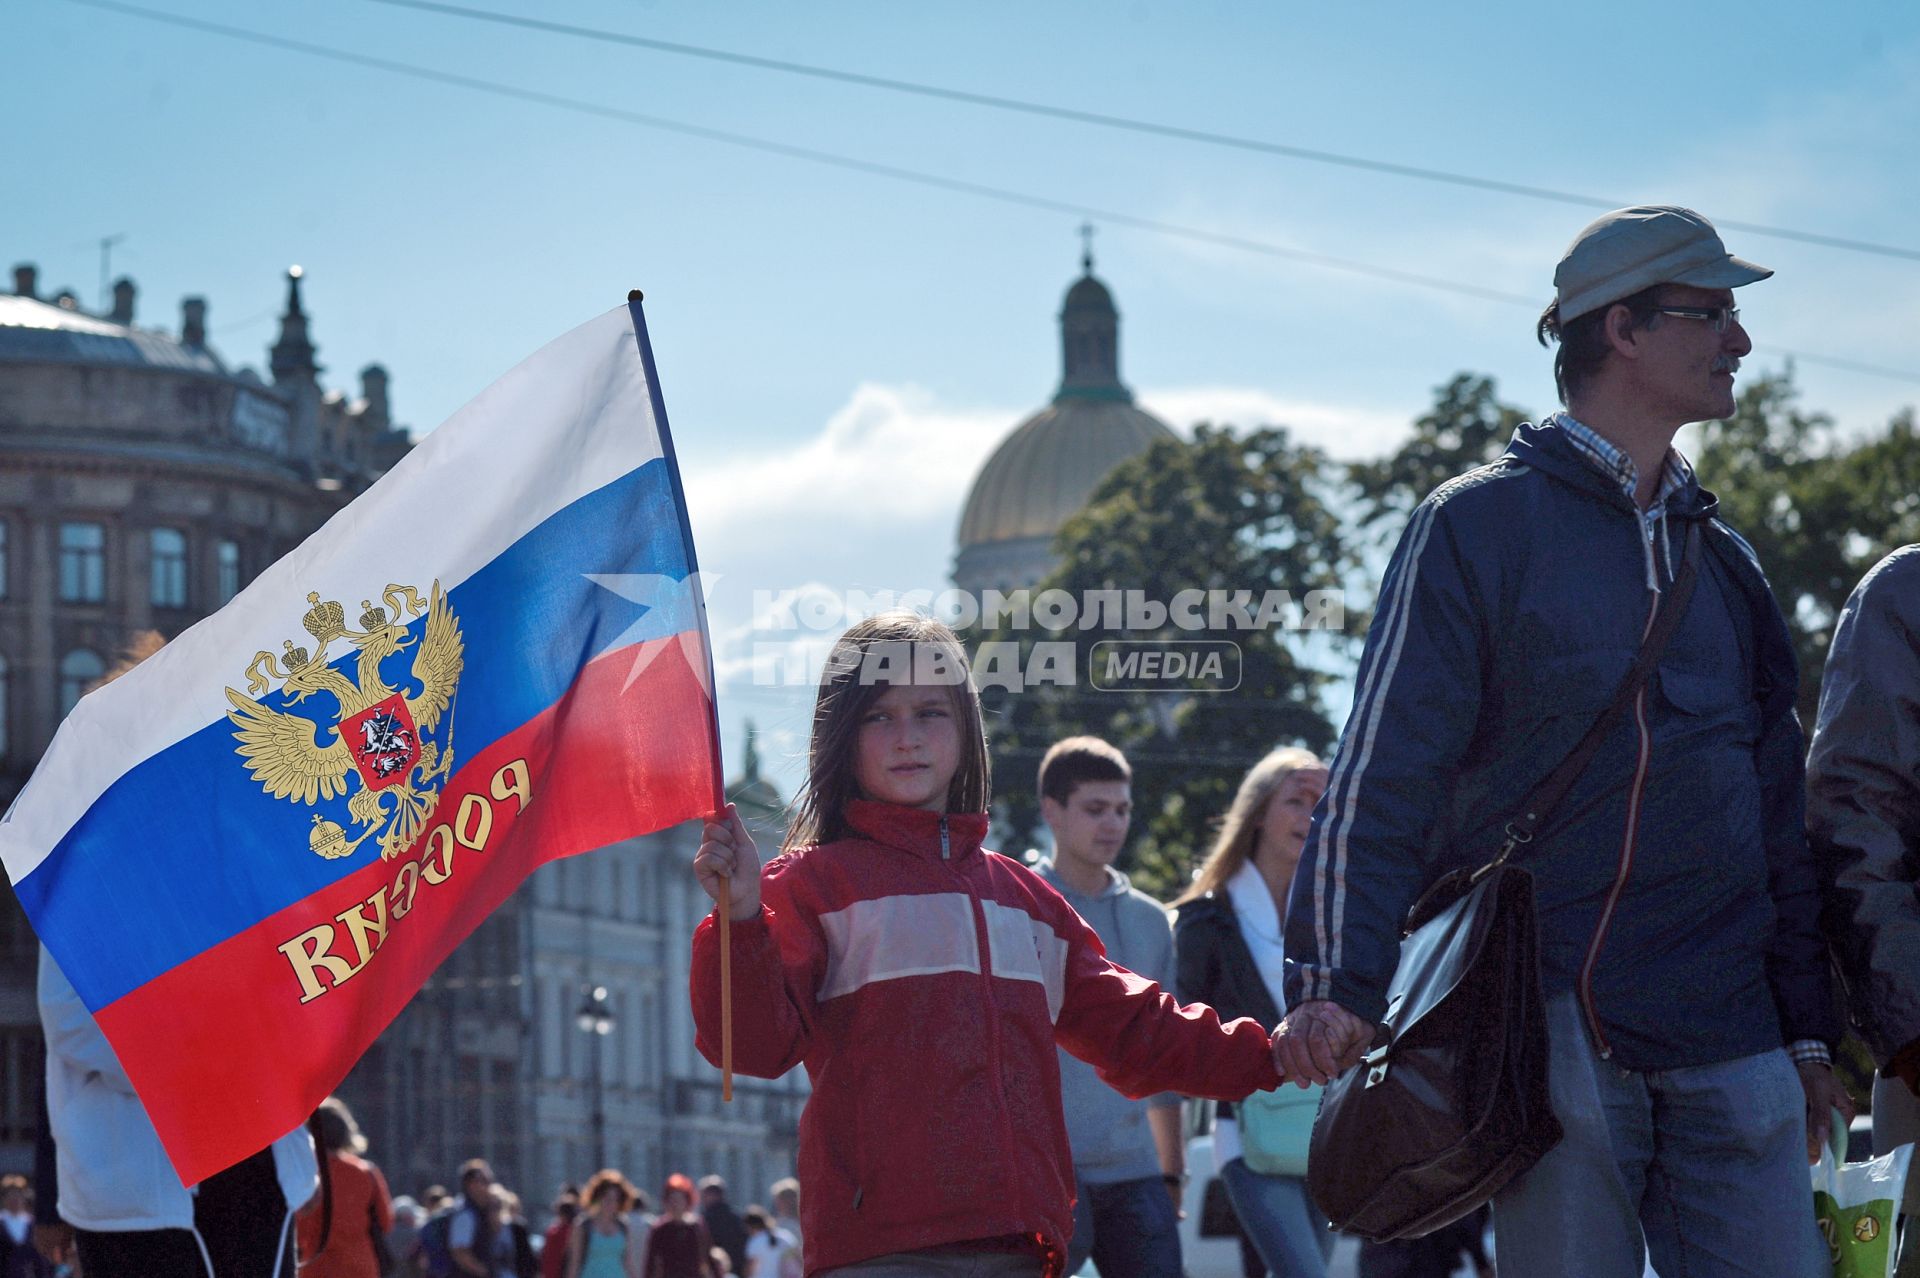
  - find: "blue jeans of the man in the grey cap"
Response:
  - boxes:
[1494,994,1832,1278]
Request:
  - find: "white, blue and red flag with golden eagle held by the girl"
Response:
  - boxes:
[0,296,722,1184]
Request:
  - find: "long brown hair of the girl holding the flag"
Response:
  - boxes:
[781,612,993,852]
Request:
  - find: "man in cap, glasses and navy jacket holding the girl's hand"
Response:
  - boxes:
[1281,205,1845,1278]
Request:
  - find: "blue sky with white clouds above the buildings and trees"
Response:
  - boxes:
[15,0,1920,798]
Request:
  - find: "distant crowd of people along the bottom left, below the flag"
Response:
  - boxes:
[16,1059,803,1278]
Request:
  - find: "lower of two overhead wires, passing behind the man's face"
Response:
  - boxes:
[67,0,1920,384]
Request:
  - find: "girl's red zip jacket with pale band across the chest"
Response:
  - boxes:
[691,800,1281,1274]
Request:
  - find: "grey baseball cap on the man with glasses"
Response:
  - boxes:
[1553,203,1772,324]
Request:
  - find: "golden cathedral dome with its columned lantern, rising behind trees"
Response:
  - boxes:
[954,251,1175,595]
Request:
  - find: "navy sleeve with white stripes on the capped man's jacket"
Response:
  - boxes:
[1286,489,1488,1023]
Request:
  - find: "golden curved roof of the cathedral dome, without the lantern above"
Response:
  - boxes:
[960,395,1175,549]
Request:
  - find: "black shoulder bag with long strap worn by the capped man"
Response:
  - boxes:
[1308,526,1699,1242]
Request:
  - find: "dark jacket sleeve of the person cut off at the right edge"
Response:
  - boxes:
[1807,547,1920,1063]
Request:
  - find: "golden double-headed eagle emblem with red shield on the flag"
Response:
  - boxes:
[227,581,467,860]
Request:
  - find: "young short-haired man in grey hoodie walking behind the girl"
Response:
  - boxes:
[1035,737,1187,1278]
